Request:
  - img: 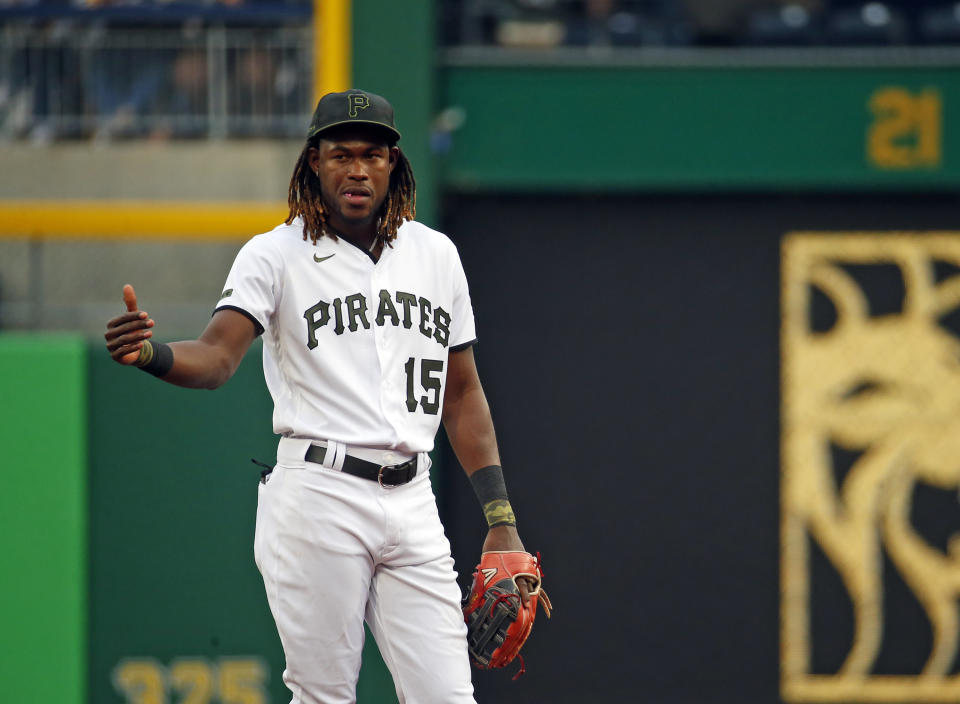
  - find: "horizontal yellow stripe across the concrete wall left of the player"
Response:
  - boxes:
[0,200,288,241]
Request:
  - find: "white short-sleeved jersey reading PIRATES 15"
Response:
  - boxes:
[217,219,476,453]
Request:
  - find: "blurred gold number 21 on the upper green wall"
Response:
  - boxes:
[867,86,943,170]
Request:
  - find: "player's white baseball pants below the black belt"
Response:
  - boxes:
[254,438,474,704]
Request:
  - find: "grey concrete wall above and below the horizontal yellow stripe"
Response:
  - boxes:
[0,141,302,335]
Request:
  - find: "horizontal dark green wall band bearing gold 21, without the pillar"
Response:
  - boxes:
[438,55,960,193]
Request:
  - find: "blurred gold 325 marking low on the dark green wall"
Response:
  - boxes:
[110,657,270,704]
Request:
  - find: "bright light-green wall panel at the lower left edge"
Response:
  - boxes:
[0,335,88,704]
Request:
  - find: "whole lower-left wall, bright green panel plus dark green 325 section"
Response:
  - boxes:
[0,335,396,704]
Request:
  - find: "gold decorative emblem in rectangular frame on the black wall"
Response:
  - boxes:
[780,233,960,702]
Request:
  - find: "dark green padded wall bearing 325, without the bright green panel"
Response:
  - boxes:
[89,342,395,704]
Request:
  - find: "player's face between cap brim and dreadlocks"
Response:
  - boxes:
[310,130,399,235]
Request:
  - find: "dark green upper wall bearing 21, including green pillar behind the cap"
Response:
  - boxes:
[352,0,960,197]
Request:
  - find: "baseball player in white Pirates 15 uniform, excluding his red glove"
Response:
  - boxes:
[105,90,536,704]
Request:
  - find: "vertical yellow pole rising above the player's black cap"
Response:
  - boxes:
[311,0,353,106]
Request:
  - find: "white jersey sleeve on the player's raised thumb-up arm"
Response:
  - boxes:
[214,235,283,335]
